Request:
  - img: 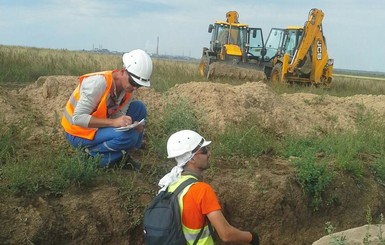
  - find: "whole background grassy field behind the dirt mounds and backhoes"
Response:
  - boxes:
[0,45,385,96]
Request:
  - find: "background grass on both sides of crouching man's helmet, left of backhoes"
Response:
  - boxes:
[0,45,203,92]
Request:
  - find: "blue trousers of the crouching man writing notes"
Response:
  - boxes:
[66,100,147,167]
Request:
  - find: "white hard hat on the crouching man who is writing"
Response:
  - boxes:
[123,49,152,87]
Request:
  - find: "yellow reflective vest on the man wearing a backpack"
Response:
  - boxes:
[168,175,214,245]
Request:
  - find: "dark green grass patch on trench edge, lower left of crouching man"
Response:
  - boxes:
[0,139,101,195]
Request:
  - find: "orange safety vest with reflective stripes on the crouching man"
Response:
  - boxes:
[61,71,131,140]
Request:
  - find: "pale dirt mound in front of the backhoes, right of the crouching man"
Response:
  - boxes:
[169,82,385,134]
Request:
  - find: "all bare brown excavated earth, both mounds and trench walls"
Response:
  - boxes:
[0,76,385,244]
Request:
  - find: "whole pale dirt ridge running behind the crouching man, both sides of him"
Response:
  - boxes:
[0,76,385,138]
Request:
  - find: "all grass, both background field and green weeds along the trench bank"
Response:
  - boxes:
[0,46,385,212]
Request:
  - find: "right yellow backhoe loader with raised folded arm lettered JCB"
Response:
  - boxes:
[263,9,334,87]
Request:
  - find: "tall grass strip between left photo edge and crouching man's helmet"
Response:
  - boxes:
[0,45,122,84]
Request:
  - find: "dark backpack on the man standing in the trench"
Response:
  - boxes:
[143,178,203,245]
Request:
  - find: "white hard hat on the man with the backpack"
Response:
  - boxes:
[167,130,211,158]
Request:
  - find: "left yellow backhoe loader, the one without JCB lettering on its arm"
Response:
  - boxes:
[199,11,264,78]
